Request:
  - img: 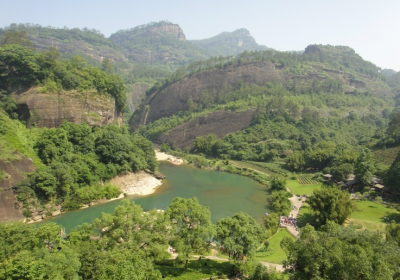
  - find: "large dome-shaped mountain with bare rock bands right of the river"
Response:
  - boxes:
[130,45,395,160]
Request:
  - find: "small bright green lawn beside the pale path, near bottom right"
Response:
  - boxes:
[255,228,294,264]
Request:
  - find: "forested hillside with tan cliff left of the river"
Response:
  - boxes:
[0,36,157,220]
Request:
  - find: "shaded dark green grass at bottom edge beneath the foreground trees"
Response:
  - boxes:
[155,259,231,280]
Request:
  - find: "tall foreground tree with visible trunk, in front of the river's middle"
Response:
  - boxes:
[166,197,215,269]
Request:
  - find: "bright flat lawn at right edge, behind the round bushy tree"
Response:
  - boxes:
[348,200,400,231]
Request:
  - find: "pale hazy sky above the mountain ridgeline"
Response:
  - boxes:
[0,0,400,71]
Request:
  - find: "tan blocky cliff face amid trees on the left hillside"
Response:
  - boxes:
[13,88,122,128]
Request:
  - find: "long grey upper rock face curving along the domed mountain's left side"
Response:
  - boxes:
[132,62,285,128]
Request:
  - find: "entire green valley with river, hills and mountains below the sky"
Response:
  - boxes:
[0,18,400,280]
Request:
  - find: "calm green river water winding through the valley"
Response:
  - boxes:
[48,162,268,232]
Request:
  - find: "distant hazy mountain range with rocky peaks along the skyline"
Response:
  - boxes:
[0,21,272,69]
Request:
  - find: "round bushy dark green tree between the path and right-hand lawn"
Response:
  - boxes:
[308,187,353,225]
